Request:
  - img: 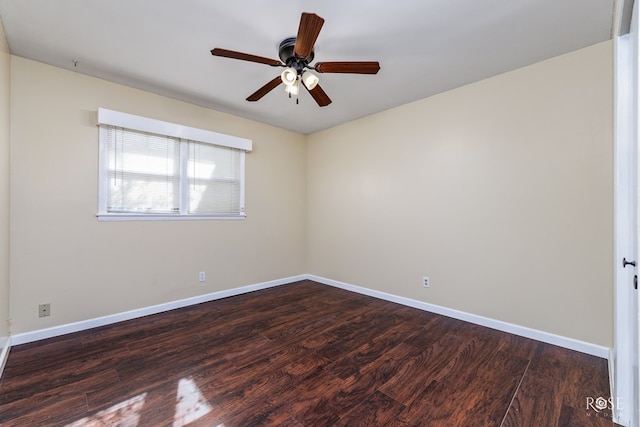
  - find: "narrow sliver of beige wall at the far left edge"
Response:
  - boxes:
[0,19,11,342]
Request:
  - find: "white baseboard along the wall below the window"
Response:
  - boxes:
[11,275,307,345]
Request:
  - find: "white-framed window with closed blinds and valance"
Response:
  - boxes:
[98,108,252,220]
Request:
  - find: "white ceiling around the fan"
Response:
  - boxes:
[0,0,614,134]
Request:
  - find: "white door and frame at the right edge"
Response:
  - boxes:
[610,0,640,427]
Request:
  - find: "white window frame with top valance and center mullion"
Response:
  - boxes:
[96,108,253,221]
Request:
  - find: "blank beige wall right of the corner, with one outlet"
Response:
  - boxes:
[307,42,613,347]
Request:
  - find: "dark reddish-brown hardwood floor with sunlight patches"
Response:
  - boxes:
[0,281,614,427]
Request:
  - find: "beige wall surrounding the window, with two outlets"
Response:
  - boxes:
[8,57,306,334]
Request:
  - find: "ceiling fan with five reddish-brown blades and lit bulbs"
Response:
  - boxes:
[211,13,380,107]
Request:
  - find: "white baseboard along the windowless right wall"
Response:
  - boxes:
[306,274,609,359]
